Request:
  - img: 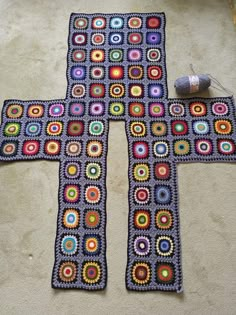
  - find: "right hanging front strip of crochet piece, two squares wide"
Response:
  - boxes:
[126,119,183,292]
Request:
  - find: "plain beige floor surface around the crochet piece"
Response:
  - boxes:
[0,0,236,315]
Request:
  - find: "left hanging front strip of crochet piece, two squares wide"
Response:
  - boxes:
[52,117,108,290]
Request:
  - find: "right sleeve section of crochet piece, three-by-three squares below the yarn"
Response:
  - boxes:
[165,97,236,162]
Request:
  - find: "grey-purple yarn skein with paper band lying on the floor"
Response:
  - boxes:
[174,74,211,94]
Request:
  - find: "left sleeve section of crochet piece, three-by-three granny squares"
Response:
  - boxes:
[0,100,67,161]
